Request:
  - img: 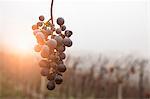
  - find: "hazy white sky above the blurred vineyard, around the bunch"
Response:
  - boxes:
[0,0,150,54]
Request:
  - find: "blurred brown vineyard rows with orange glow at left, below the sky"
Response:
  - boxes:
[0,51,150,99]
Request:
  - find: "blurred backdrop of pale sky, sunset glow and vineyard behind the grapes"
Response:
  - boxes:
[0,0,150,99]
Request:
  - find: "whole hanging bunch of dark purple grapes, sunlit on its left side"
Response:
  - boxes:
[32,15,72,90]
